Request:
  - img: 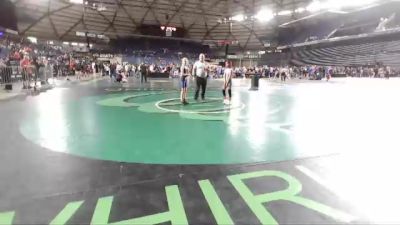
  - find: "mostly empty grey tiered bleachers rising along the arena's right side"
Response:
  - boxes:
[268,2,400,68]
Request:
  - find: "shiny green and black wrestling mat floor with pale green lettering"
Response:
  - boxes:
[0,78,400,225]
